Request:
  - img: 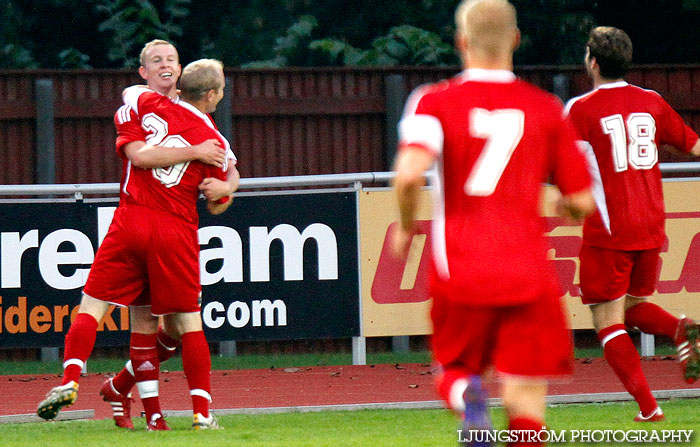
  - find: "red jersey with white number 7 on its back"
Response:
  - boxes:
[399,70,590,306]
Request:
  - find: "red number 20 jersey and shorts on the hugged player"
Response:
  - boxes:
[85,86,236,315]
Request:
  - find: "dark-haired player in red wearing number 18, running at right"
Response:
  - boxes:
[566,27,700,421]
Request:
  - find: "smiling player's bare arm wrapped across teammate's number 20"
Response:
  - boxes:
[124,139,226,169]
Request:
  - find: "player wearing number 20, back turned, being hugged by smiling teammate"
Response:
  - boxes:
[37,59,235,430]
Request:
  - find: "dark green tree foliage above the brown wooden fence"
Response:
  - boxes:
[0,0,700,68]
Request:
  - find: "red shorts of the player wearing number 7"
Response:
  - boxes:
[431,295,573,378]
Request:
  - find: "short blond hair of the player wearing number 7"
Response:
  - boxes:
[455,0,518,56]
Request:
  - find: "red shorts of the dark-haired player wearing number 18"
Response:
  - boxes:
[579,244,661,304]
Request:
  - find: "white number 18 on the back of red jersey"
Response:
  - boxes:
[600,113,659,172]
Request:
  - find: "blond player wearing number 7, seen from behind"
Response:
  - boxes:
[393,0,594,445]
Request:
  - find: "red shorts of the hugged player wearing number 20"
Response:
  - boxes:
[83,205,201,315]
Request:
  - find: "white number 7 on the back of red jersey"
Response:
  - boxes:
[464,109,525,196]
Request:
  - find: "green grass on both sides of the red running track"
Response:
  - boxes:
[0,347,700,447]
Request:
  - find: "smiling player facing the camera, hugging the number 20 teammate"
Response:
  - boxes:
[100,39,238,429]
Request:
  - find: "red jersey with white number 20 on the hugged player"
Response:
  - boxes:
[115,86,236,228]
